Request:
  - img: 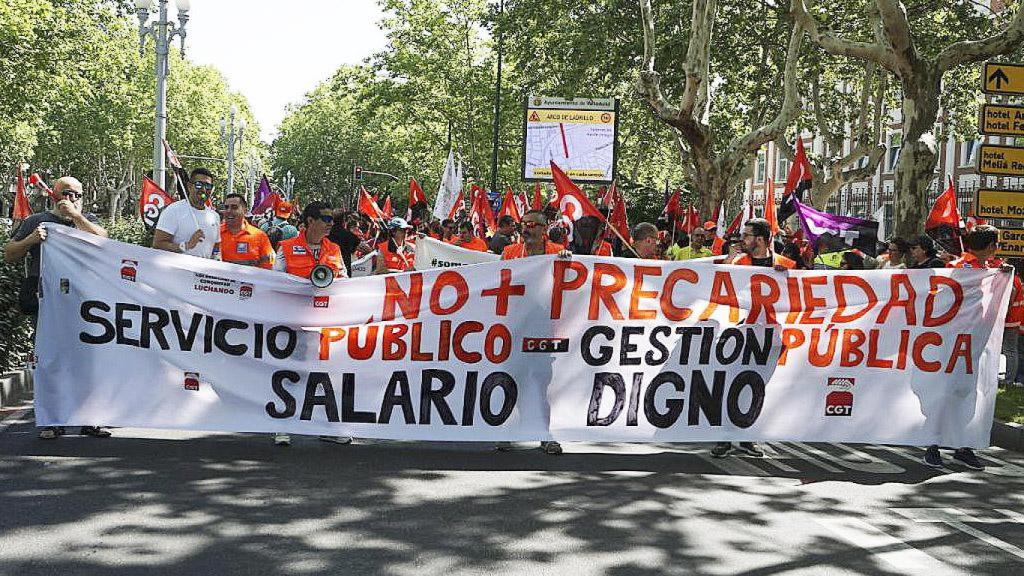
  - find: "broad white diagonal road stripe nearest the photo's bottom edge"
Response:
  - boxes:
[815,518,958,576]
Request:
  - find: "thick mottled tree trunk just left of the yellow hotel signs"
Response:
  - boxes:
[895,66,942,238]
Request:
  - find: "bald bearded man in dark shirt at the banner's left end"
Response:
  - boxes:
[3,176,111,440]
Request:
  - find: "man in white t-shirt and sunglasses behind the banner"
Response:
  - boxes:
[153,168,220,258]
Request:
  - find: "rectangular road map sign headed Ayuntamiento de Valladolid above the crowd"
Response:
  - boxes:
[523,96,616,182]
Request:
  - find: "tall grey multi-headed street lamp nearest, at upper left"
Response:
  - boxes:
[135,0,191,190]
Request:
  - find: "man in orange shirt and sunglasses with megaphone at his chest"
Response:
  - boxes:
[273,201,352,446]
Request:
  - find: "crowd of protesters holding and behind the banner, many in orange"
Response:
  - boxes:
[4,168,1024,469]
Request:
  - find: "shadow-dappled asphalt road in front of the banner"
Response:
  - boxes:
[0,403,1024,576]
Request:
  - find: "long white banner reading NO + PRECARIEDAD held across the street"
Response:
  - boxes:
[35,227,1011,447]
